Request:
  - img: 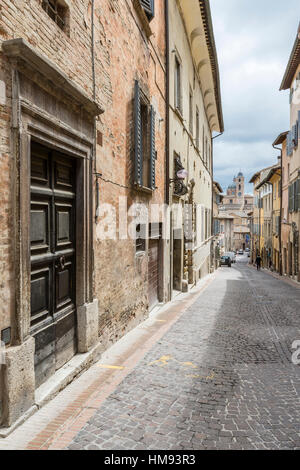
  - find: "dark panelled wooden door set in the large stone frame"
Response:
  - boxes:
[30,143,76,386]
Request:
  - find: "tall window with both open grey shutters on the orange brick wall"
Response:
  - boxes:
[134,81,156,190]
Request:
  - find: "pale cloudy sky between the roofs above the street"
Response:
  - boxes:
[210,0,300,195]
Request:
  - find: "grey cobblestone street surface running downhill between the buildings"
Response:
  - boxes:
[64,262,300,450]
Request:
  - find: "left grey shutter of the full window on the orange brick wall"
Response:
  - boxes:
[134,80,143,186]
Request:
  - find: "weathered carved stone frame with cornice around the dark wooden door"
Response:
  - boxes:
[2,39,103,425]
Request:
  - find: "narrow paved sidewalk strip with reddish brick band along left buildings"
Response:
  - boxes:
[0,273,216,450]
